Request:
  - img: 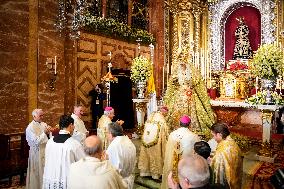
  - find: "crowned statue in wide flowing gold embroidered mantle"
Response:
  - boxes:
[164,45,215,138]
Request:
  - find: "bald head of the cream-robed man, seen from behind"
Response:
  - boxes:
[84,135,102,156]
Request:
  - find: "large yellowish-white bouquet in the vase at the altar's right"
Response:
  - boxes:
[251,44,284,79]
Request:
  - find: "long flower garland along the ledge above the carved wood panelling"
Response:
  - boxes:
[84,13,155,44]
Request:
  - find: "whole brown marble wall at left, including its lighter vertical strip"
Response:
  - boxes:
[0,0,65,133]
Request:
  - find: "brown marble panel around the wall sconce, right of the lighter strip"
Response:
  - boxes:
[37,0,66,125]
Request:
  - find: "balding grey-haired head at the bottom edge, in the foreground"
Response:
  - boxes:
[178,154,210,187]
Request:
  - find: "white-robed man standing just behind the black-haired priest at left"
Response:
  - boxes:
[71,105,89,143]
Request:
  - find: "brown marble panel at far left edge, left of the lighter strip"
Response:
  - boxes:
[0,0,29,132]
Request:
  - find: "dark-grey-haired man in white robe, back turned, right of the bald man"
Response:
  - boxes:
[106,122,136,189]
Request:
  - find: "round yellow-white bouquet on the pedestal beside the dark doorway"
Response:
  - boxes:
[130,55,152,83]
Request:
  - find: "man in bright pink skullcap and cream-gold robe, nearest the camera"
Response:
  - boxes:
[161,115,200,189]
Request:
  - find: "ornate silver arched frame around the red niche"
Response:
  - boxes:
[208,0,276,71]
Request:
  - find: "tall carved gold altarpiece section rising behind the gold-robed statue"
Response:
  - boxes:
[165,0,210,86]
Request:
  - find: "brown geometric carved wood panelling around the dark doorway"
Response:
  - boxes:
[75,33,150,121]
